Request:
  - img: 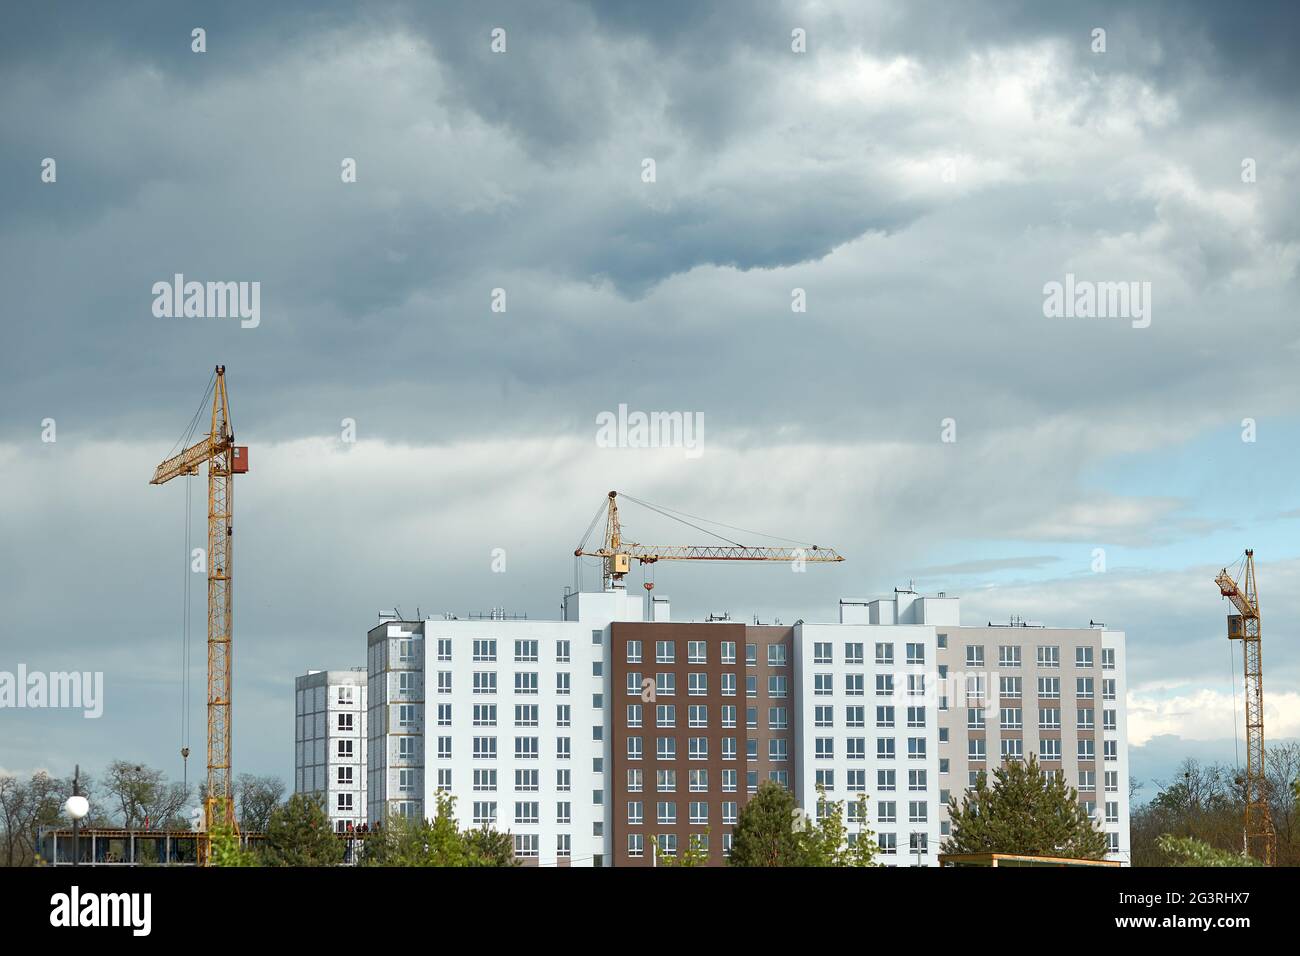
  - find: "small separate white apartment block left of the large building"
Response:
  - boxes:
[294,667,368,832]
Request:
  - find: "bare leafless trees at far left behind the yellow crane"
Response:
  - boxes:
[0,760,286,866]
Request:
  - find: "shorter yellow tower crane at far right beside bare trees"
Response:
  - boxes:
[1214,550,1277,866]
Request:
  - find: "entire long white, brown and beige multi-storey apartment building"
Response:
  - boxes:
[345,589,1128,866]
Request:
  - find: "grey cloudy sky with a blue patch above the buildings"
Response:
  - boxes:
[0,0,1300,796]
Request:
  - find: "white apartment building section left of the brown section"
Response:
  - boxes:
[368,591,650,866]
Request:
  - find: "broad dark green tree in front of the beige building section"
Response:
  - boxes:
[944,754,1106,860]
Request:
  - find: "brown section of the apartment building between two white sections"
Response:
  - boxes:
[606,622,796,866]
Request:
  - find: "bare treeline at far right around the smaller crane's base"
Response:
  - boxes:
[1130,741,1300,866]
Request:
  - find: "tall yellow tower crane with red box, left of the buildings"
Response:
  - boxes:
[150,365,248,865]
